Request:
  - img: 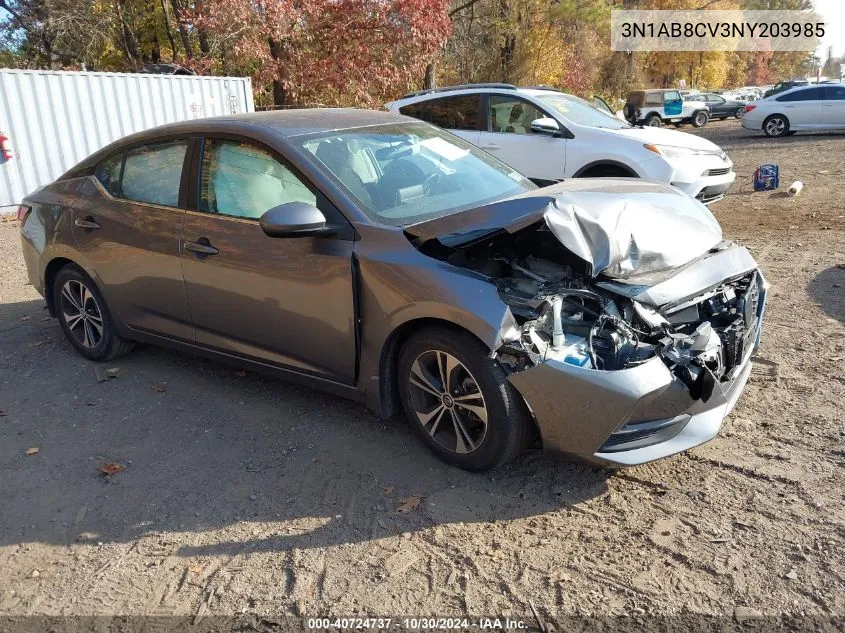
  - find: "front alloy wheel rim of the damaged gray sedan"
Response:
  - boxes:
[409,350,488,454]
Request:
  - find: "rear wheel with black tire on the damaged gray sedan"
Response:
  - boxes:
[53,264,134,361]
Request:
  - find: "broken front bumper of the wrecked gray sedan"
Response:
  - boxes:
[509,276,766,466]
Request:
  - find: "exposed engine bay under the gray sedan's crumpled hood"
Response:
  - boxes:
[425,222,759,401]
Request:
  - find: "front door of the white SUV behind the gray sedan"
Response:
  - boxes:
[478,94,566,184]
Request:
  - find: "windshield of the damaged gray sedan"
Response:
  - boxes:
[301,123,536,226]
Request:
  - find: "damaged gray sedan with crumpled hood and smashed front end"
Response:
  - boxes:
[18,110,767,470]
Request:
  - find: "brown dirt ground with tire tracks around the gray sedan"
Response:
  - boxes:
[0,121,845,630]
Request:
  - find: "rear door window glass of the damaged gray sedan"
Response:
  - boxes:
[120,140,188,207]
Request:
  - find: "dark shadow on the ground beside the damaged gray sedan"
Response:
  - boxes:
[0,301,610,556]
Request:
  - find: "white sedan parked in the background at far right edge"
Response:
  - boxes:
[742,84,845,137]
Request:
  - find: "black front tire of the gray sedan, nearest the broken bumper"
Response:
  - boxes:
[398,327,532,471]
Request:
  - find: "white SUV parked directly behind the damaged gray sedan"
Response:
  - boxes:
[385,84,736,203]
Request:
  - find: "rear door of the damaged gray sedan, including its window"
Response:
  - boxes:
[73,138,194,341]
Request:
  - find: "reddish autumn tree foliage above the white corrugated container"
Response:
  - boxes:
[189,0,450,107]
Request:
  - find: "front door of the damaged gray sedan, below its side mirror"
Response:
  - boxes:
[181,137,356,384]
